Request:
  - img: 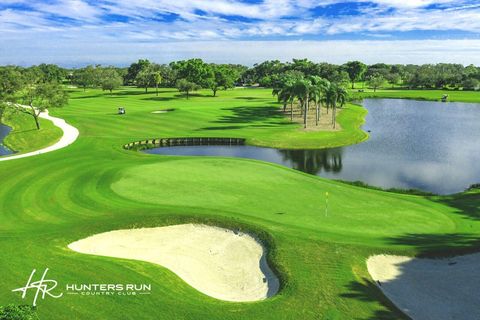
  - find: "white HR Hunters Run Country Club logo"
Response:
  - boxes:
[12,268,152,307]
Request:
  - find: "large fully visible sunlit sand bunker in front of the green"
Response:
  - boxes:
[68,224,279,302]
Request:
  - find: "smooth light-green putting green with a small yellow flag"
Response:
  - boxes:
[112,156,455,243]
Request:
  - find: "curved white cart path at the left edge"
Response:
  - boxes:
[0,107,79,161]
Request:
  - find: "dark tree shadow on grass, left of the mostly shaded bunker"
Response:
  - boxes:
[341,278,410,320]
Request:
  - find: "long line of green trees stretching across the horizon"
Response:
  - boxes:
[0,59,480,95]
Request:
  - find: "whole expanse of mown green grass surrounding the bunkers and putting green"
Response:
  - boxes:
[0,89,480,319]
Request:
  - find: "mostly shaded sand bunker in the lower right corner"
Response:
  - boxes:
[367,253,480,320]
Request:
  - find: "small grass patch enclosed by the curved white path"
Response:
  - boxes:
[2,109,63,153]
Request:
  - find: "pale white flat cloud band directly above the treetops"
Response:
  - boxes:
[0,36,480,66]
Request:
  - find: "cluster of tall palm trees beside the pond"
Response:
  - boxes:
[272,76,348,128]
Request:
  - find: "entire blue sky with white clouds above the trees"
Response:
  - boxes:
[0,0,480,67]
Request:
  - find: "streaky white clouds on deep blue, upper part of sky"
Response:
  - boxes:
[0,0,480,65]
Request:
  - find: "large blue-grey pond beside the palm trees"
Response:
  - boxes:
[146,99,480,194]
